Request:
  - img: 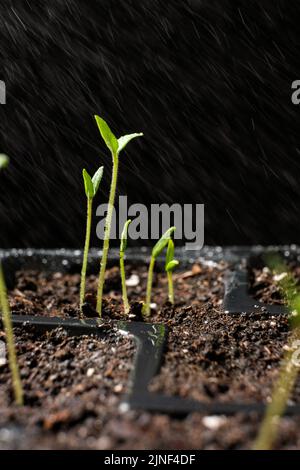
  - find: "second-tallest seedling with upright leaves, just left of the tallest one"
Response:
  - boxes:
[80,166,103,315]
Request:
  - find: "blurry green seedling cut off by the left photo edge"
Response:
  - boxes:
[0,154,24,405]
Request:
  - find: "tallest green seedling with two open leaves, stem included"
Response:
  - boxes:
[95,116,143,317]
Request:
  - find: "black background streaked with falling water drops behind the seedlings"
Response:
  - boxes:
[0,0,300,247]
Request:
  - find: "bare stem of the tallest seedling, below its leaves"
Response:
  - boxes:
[97,154,119,318]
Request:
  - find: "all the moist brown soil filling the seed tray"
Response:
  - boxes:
[0,263,300,449]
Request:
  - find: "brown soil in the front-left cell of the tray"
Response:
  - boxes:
[0,327,134,449]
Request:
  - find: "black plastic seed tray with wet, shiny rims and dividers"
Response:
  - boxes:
[0,246,300,415]
